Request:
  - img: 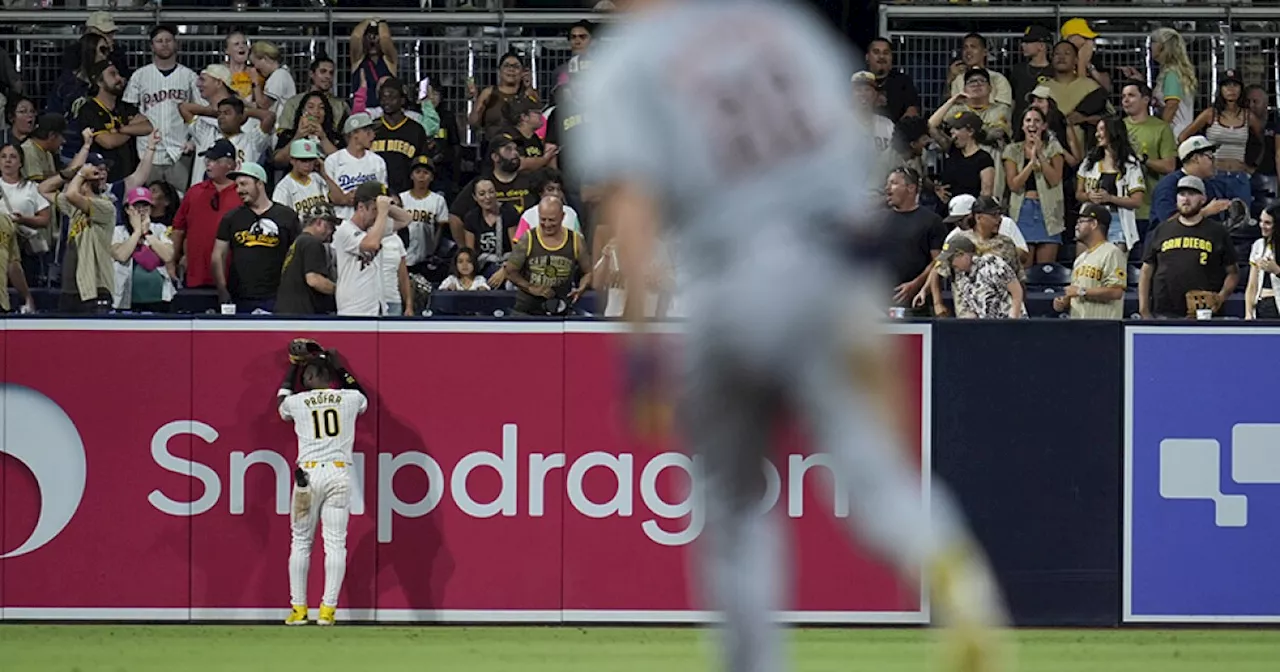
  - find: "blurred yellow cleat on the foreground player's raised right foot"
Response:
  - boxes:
[929,548,1012,672]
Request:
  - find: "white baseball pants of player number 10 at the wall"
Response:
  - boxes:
[289,462,352,607]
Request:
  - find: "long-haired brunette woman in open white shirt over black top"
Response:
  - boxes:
[1075,118,1147,252]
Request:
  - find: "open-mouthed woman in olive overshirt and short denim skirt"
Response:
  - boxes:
[1002,108,1066,264]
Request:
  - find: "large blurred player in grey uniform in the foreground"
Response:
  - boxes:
[576,0,1004,672]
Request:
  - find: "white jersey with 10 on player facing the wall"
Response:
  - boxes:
[280,389,369,463]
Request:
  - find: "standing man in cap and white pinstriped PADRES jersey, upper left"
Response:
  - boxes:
[123,26,198,191]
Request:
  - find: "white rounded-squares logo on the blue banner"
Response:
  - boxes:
[1160,424,1280,527]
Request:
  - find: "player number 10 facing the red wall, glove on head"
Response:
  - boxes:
[278,338,369,626]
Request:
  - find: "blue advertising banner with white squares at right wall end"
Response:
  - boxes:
[1123,326,1280,623]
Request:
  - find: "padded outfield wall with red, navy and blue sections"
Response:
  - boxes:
[0,317,1280,625]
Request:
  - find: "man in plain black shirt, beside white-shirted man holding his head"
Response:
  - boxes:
[273,216,338,315]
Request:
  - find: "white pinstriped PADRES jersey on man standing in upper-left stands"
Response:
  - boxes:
[124,63,200,165]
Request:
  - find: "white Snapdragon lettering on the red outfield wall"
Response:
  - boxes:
[147,420,849,547]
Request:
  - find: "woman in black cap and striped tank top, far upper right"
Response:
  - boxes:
[1178,70,1266,206]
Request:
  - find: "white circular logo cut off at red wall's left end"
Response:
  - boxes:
[0,384,86,559]
